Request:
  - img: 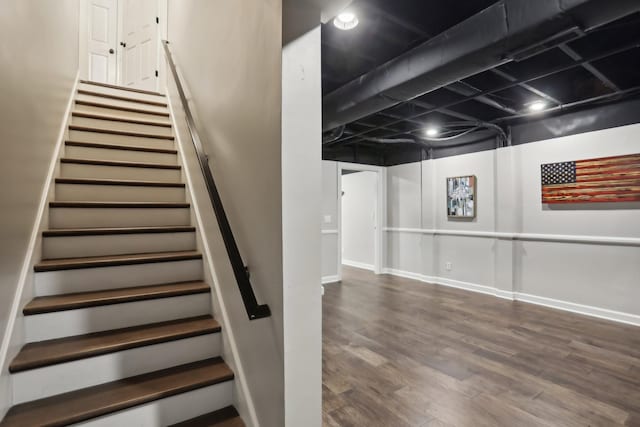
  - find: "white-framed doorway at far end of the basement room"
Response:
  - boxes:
[338,164,384,277]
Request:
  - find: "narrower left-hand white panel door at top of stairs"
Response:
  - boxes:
[87,0,118,84]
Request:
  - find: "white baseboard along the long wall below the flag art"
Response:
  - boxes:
[383,268,640,326]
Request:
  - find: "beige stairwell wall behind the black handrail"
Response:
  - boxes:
[168,0,285,426]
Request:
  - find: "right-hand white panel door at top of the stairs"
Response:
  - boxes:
[122,0,158,90]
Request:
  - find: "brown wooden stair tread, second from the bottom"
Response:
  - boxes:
[0,358,234,427]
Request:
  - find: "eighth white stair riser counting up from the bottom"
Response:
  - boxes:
[60,163,182,182]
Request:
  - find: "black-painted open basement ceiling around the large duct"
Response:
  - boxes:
[322,0,640,164]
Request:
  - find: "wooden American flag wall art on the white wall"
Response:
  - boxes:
[541,154,640,204]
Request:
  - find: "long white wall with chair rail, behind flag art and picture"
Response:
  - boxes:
[386,125,640,323]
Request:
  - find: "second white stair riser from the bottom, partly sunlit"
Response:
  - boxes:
[12,333,221,405]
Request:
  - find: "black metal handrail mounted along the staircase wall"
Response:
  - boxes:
[162,40,271,320]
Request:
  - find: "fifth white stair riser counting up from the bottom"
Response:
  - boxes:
[42,233,196,259]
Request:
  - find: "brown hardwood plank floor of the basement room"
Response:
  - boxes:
[323,267,640,427]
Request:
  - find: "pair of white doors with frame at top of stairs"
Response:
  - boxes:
[79,0,167,92]
